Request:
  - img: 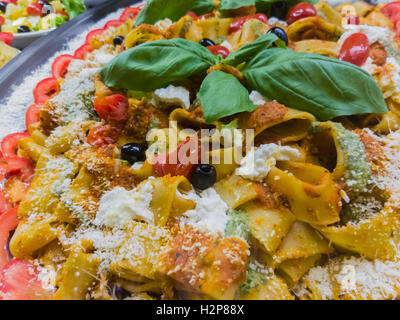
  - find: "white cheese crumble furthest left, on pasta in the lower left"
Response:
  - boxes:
[94,181,154,228]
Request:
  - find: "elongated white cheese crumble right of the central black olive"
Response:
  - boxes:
[236,143,304,181]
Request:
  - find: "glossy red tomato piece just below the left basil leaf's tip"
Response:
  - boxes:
[93,94,128,124]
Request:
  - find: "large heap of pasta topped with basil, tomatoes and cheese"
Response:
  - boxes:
[0,0,400,300]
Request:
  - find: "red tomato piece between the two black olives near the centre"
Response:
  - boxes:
[153,139,201,179]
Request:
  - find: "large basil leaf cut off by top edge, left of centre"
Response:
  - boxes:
[135,0,215,26]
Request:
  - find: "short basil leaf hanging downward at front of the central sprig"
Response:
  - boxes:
[197,71,257,123]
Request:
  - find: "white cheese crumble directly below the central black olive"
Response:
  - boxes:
[179,188,229,235]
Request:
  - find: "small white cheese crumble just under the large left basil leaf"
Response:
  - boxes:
[153,85,190,109]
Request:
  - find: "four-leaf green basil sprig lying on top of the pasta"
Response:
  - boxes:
[99,34,387,123]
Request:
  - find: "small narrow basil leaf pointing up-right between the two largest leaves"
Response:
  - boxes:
[222,33,286,66]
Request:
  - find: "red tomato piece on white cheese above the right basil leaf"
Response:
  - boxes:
[339,33,369,67]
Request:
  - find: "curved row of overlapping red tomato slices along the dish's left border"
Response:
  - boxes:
[0,6,142,300]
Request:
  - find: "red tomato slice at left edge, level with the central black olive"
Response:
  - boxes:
[0,157,35,183]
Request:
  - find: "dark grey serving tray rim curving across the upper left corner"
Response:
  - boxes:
[0,0,140,104]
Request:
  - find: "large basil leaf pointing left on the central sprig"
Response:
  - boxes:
[99,38,220,92]
